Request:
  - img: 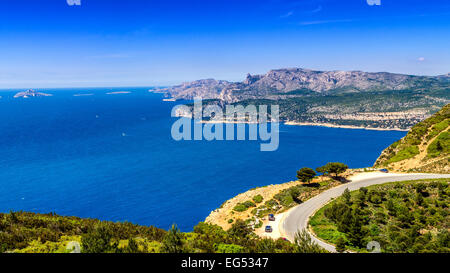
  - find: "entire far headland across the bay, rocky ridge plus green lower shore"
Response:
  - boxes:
[159,68,450,130]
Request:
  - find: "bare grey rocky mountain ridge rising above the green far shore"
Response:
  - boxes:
[156,68,450,103]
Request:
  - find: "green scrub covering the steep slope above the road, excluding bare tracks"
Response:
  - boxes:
[375,104,450,172]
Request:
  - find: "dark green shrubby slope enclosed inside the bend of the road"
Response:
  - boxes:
[310,179,450,253]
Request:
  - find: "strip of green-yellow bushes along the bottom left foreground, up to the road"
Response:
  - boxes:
[0,212,323,253]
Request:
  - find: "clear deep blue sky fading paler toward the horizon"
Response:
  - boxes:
[0,0,450,89]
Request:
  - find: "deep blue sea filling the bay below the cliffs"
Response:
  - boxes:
[0,88,405,231]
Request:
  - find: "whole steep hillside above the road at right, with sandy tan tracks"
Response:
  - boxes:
[375,104,450,173]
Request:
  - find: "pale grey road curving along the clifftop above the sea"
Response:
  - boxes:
[280,173,450,252]
